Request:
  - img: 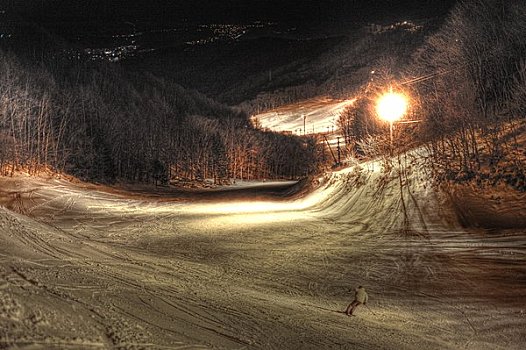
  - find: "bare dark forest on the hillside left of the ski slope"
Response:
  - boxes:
[0,52,324,183]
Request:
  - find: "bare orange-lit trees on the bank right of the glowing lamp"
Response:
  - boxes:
[411,0,526,190]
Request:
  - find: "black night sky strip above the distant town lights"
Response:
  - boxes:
[5,0,455,23]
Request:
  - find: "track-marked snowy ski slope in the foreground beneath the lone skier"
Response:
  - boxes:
[0,156,526,349]
